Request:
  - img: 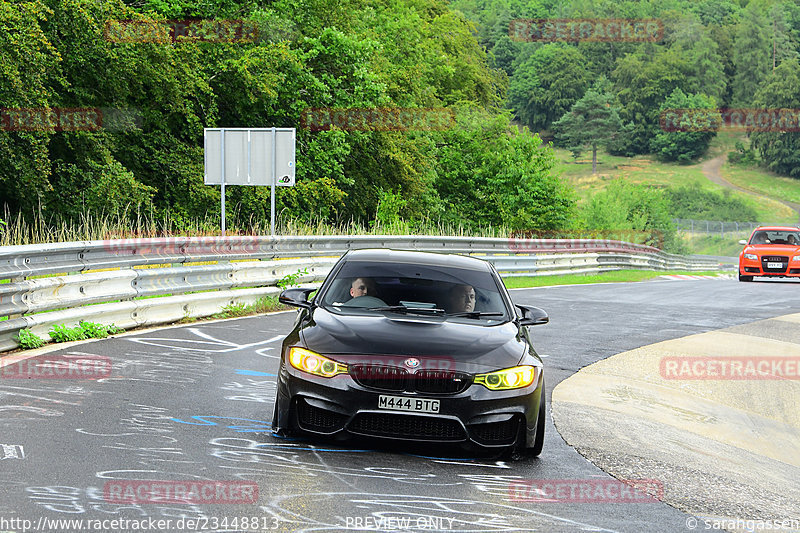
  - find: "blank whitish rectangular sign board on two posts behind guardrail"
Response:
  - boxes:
[204,128,296,187]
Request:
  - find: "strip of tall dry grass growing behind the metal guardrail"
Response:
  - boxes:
[0,212,511,246]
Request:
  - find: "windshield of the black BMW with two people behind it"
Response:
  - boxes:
[320,261,510,322]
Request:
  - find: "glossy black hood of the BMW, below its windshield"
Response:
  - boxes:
[301,308,526,372]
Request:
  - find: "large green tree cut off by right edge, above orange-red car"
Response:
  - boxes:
[750,58,800,178]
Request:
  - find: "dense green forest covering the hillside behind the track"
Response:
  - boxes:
[0,0,800,245]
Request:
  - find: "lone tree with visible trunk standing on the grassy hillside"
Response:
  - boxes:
[553,81,622,174]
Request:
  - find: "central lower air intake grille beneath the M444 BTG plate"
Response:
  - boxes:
[347,413,466,441]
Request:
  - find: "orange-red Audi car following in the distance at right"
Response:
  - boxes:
[739,226,800,281]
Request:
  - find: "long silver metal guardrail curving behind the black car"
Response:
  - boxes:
[0,235,718,351]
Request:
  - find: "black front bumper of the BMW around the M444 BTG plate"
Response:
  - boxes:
[273,364,544,448]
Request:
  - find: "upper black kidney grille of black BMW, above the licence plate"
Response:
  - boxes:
[349,365,472,394]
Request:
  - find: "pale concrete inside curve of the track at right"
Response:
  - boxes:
[545,313,800,530]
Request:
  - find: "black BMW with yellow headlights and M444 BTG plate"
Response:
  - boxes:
[272,250,548,456]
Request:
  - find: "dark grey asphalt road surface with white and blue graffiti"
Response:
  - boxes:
[0,280,800,533]
